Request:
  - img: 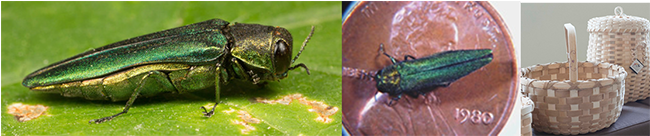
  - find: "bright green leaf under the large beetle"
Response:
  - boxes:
[1,2,342,135]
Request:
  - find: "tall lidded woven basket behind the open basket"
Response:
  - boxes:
[587,7,650,102]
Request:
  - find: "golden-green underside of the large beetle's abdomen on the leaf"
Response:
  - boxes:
[31,64,190,101]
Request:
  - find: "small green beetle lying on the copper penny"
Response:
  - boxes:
[374,44,492,105]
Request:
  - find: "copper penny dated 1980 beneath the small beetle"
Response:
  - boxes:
[342,2,518,135]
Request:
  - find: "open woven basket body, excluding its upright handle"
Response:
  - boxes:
[521,62,627,135]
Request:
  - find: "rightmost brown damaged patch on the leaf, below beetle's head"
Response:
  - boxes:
[256,94,339,123]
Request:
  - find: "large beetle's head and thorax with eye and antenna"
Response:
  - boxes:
[230,23,314,81]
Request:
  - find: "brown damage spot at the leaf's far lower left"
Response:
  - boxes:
[7,103,48,122]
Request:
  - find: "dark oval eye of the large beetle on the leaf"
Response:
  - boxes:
[274,40,291,75]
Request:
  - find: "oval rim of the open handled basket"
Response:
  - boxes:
[519,61,627,84]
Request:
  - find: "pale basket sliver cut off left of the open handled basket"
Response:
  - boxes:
[521,95,535,136]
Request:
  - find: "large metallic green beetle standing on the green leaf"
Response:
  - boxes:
[23,19,314,123]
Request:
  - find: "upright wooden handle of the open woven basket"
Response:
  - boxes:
[564,23,578,82]
